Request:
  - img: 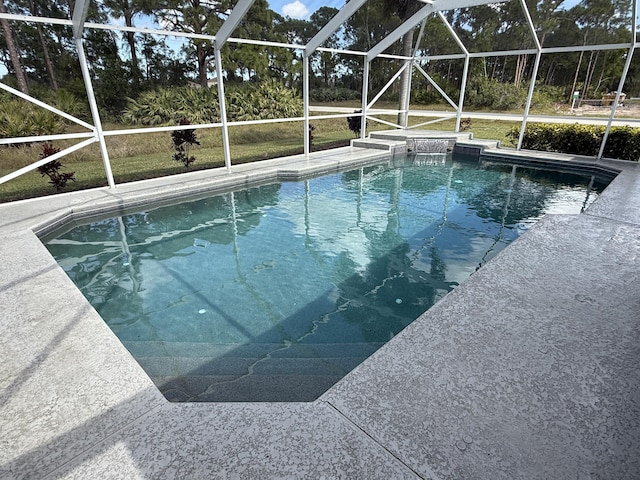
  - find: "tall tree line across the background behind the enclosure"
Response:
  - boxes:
[0,0,640,122]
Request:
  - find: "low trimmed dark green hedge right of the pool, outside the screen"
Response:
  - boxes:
[507,123,640,162]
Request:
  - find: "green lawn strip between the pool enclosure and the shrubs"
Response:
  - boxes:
[0,117,516,202]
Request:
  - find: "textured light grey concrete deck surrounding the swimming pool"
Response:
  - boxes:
[0,132,640,480]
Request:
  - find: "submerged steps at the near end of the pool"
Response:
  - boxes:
[124,342,383,402]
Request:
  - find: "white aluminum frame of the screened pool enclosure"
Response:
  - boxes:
[0,0,639,188]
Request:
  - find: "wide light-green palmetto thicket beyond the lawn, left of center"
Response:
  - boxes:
[122,80,302,125]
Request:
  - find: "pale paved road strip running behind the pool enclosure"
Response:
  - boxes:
[309,106,640,127]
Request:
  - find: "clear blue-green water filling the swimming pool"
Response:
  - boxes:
[45,157,602,402]
